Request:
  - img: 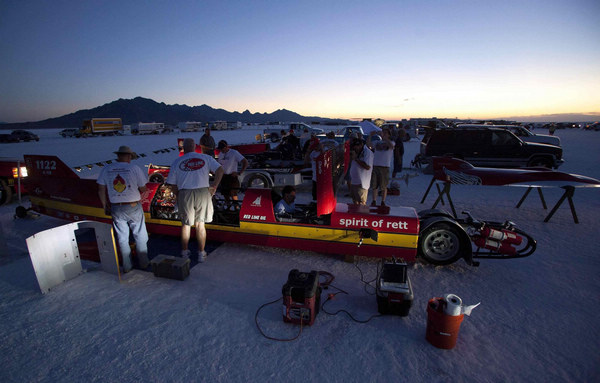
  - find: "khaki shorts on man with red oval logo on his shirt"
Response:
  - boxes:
[177,188,214,226]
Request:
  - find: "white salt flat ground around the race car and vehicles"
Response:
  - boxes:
[0,130,600,382]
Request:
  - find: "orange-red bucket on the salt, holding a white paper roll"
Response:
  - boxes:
[425,298,464,350]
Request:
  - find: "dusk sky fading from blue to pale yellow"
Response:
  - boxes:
[0,0,600,122]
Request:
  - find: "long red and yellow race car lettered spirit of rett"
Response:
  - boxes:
[24,151,536,265]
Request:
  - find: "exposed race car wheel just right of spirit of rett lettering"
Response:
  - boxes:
[419,222,461,265]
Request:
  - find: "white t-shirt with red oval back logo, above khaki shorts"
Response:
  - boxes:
[166,152,221,190]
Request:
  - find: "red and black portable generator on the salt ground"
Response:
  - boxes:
[281,269,322,326]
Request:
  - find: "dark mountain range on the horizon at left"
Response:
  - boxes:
[0,97,347,129]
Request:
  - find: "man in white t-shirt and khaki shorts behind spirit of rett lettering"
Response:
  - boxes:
[350,138,373,205]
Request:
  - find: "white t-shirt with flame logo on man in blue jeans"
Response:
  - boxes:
[96,162,147,203]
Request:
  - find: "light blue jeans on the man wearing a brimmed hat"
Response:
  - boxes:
[111,203,148,271]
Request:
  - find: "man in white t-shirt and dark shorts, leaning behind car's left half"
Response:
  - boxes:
[217,140,248,210]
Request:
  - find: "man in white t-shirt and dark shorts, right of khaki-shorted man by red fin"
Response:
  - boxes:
[367,129,395,206]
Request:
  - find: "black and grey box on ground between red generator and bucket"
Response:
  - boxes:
[375,259,414,316]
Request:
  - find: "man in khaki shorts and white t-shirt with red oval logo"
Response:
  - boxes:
[166,138,223,262]
